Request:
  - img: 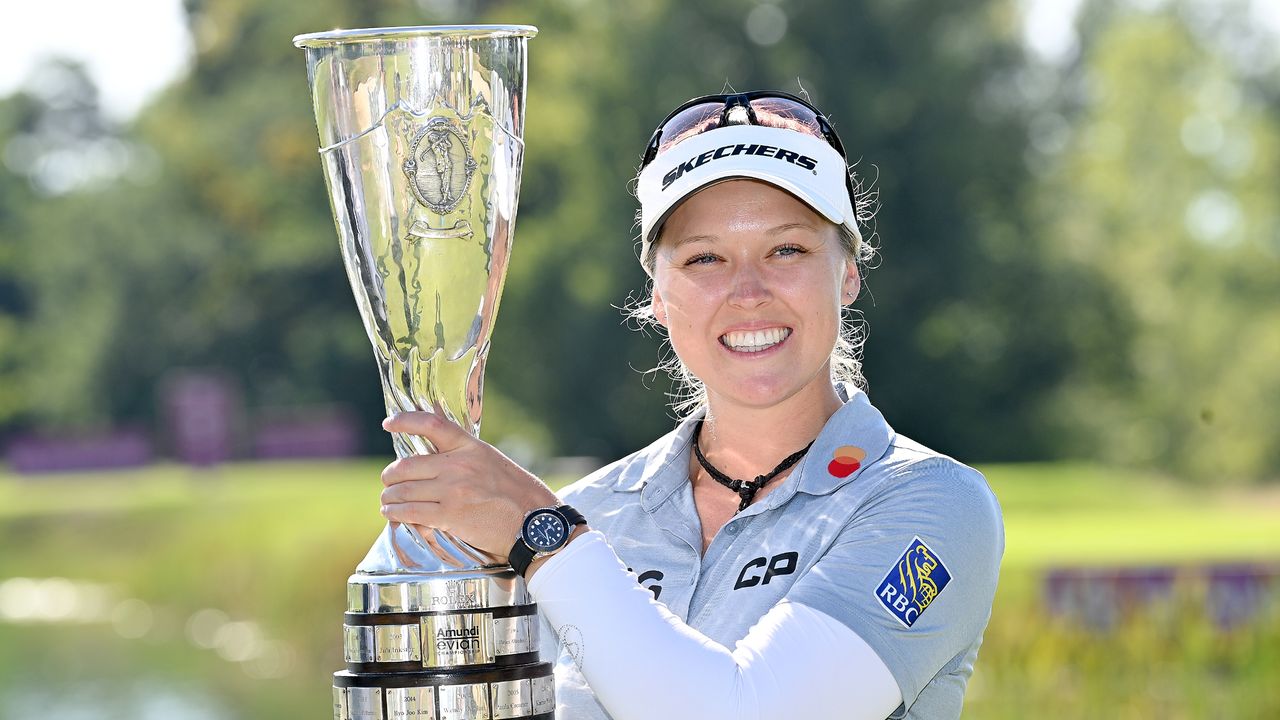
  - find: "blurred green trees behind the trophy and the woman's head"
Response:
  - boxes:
[0,0,1280,483]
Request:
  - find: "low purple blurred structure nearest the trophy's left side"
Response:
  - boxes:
[253,406,360,460]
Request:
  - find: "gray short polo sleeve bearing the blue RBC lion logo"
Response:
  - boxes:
[790,433,1005,716]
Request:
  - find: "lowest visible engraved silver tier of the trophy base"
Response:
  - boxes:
[333,662,556,720]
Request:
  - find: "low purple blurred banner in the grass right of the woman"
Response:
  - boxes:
[1044,562,1280,630]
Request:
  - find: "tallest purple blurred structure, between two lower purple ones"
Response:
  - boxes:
[160,370,242,466]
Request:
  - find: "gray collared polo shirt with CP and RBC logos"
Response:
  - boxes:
[543,387,1005,720]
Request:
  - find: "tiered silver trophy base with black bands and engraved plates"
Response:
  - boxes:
[333,568,556,720]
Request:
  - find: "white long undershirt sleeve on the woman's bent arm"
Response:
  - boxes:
[529,532,901,720]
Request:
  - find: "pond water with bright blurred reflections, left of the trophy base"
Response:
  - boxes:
[0,579,330,720]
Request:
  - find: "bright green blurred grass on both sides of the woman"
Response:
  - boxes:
[0,460,1280,719]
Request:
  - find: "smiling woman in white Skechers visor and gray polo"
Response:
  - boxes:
[383,92,1004,720]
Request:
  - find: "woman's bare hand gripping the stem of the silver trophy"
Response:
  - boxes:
[381,411,559,560]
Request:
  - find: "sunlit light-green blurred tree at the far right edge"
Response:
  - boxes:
[1041,3,1280,480]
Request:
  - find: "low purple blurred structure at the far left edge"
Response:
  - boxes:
[5,430,152,474]
